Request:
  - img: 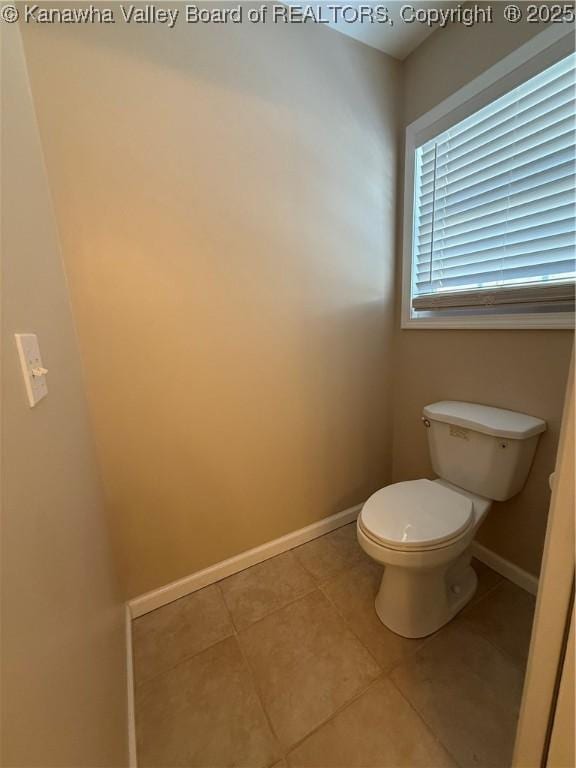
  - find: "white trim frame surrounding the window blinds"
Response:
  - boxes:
[401,24,575,329]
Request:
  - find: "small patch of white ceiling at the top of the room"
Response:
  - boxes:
[285,0,462,59]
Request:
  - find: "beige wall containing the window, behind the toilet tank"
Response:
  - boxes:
[393,12,572,573]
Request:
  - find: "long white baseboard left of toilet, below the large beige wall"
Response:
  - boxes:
[128,504,362,619]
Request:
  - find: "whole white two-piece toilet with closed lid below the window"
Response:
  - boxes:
[357,401,546,637]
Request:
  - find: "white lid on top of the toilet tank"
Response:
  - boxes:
[423,400,546,440]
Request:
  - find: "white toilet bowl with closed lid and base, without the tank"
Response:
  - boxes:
[357,480,492,637]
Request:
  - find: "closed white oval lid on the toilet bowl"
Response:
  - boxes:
[360,480,473,550]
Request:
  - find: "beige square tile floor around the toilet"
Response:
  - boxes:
[133,524,534,768]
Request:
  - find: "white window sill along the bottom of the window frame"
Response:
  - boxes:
[401,312,575,331]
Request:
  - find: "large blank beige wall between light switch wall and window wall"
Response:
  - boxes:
[21,15,400,596]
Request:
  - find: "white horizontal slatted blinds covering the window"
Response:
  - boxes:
[412,54,576,309]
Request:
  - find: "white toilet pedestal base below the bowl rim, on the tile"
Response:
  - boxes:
[376,548,478,638]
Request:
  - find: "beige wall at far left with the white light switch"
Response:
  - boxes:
[0,25,126,768]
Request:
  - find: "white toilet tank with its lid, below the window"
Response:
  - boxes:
[422,400,546,501]
